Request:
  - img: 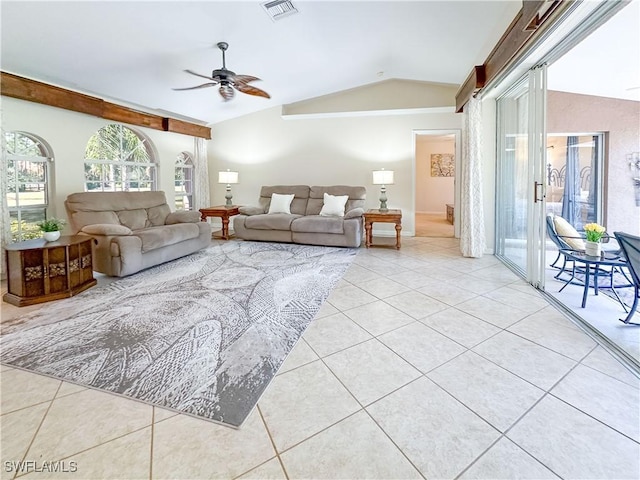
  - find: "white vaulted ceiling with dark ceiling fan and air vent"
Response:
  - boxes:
[0,0,522,124]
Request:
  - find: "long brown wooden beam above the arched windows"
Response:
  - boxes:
[0,72,211,140]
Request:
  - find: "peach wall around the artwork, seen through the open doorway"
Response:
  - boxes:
[416,135,456,214]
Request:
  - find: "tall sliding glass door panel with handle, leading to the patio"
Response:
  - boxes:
[496,65,546,287]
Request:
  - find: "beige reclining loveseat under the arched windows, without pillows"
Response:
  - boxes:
[65,192,211,277]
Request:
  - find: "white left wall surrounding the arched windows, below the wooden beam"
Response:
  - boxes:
[1,97,194,230]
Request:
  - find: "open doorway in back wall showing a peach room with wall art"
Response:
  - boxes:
[414,130,460,238]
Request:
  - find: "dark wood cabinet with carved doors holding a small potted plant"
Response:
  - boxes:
[2,235,97,307]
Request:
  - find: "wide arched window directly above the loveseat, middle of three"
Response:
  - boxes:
[84,124,157,192]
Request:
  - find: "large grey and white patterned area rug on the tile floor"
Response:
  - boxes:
[0,242,357,427]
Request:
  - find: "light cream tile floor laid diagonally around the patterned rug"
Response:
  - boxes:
[0,238,640,479]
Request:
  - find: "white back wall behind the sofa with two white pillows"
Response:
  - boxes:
[208,108,462,235]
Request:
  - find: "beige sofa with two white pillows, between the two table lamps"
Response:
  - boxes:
[233,185,367,247]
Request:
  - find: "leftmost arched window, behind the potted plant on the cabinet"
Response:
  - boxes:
[5,132,53,242]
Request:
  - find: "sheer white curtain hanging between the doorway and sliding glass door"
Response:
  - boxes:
[460,97,486,258]
